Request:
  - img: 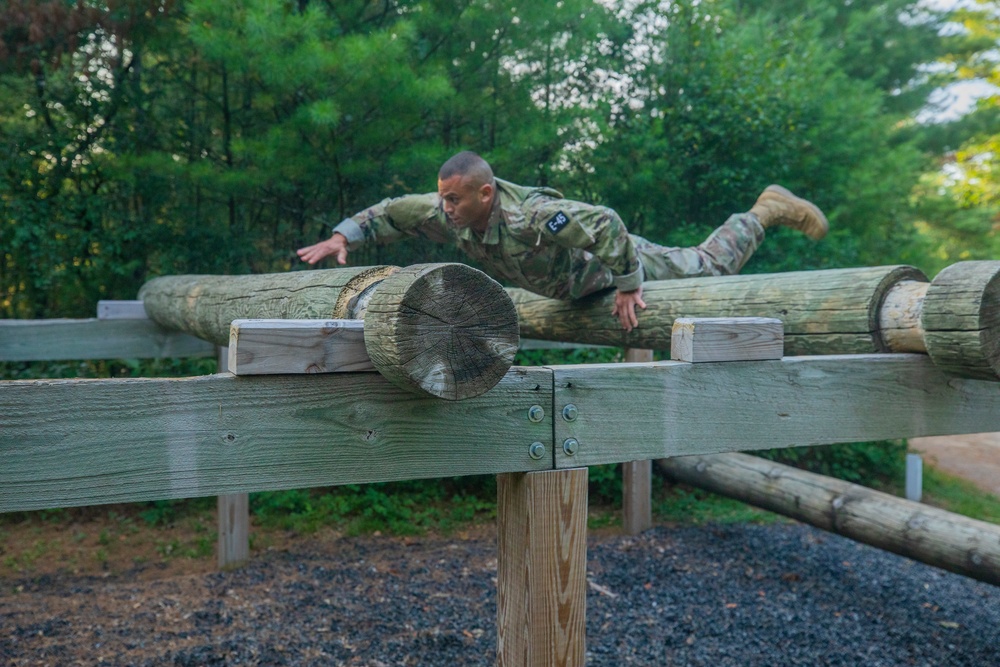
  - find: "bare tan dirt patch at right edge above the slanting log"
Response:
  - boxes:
[909,433,1000,496]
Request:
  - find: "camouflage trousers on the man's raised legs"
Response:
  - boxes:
[629,213,764,280]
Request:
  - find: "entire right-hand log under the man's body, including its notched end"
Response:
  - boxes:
[507,261,1000,380]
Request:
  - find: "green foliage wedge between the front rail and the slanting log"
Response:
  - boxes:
[754,440,906,488]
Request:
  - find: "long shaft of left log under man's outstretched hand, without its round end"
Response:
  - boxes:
[139,266,398,346]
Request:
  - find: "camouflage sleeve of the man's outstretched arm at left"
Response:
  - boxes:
[333,193,454,250]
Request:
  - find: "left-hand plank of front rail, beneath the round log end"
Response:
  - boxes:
[0,368,552,512]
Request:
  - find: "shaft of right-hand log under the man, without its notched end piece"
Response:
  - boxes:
[508,266,927,355]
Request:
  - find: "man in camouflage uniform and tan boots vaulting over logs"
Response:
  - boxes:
[298,151,828,331]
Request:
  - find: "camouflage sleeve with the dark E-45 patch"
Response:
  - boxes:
[532,199,643,292]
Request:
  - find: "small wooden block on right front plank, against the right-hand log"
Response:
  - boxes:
[670,317,784,363]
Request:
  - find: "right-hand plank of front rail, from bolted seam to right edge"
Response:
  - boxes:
[552,354,1000,467]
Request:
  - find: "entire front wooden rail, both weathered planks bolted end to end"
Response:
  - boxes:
[0,354,1000,511]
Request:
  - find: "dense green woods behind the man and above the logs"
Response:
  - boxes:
[0,0,1000,318]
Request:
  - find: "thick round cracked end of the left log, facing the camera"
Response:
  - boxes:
[365,264,519,400]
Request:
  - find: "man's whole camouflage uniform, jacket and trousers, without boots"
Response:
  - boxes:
[334,179,764,300]
